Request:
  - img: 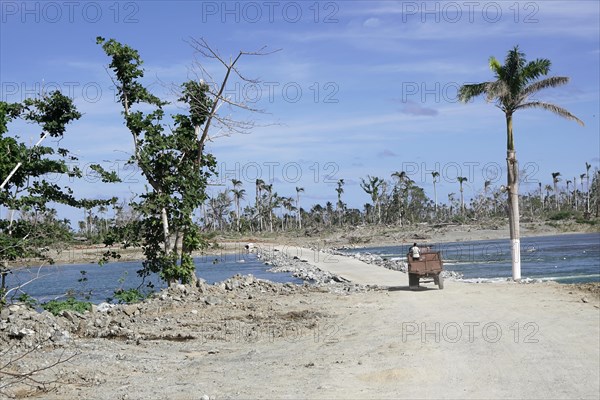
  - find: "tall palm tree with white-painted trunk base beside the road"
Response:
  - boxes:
[459,46,583,280]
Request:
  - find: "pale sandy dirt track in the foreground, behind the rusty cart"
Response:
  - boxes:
[17,249,600,399]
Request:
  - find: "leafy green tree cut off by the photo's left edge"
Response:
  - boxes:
[0,91,118,302]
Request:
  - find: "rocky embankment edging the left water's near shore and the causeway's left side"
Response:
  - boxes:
[0,250,380,354]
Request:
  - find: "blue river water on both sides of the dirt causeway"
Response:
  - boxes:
[7,233,600,303]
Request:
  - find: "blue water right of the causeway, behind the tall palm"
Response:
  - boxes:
[340,233,600,283]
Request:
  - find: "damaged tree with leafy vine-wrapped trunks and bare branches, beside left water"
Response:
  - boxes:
[97,37,276,283]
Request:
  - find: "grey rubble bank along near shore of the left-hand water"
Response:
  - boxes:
[0,275,324,348]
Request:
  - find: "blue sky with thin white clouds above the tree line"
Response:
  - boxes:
[0,1,600,222]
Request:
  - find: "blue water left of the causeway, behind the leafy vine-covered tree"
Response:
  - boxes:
[6,254,303,304]
